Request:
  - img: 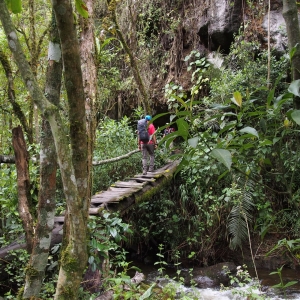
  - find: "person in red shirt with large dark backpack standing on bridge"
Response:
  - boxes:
[138,115,157,175]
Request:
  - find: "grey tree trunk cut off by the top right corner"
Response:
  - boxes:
[282,0,300,109]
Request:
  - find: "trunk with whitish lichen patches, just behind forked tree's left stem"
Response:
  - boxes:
[23,13,62,299]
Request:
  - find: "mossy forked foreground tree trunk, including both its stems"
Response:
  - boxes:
[0,0,89,299]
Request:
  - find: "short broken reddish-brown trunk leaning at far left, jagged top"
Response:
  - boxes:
[12,126,34,253]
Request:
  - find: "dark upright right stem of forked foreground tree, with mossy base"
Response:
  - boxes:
[52,0,90,299]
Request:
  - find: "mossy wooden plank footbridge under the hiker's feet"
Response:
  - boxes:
[54,161,179,224]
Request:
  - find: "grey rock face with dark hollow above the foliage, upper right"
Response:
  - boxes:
[183,0,287,53]
